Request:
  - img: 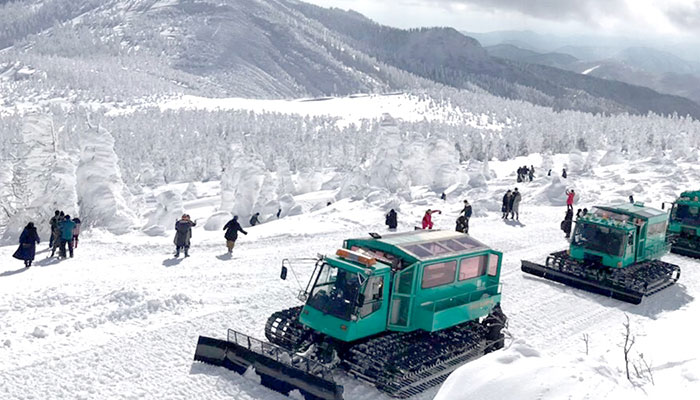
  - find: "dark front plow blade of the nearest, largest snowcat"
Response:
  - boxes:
[194,329,343,400]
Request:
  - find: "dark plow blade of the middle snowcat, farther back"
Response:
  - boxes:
[520,260,644,304]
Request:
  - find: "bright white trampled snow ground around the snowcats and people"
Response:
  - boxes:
[0,153,700,400]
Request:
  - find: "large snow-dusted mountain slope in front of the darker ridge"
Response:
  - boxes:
[0,0,700,119]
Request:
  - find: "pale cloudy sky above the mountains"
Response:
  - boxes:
[303,0,700,39]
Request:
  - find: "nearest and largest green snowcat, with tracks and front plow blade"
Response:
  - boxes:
[194,230,506,400]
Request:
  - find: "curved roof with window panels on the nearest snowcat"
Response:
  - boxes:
[348,230,490,261]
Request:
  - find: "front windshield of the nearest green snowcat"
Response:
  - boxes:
[307,264,364,321]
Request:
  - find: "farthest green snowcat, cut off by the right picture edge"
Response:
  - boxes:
[664,190,700,258]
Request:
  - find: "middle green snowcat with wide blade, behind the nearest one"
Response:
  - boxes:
[521,203,681,304]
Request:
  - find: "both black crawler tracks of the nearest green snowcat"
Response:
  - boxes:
[265,307,505,398]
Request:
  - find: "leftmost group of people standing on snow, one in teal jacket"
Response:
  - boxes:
[12,210,81,268]
